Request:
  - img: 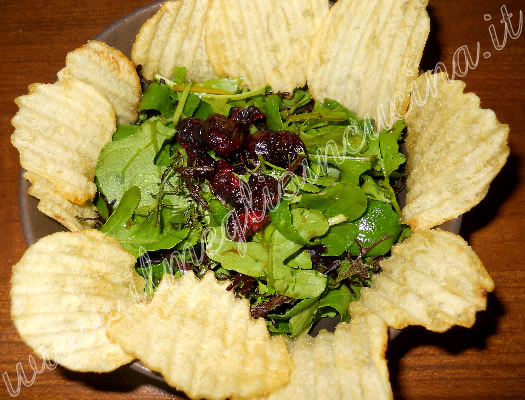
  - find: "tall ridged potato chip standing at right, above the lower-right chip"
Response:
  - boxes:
[402,72,509,230]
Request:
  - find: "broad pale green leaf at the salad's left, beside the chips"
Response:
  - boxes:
[96,120,175,213]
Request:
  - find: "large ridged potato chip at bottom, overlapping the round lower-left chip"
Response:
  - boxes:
[108,272,293,399]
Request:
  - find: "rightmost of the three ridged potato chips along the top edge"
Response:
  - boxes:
[306,0,430,130]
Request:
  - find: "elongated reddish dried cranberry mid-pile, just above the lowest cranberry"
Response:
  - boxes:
[209,160,245,207]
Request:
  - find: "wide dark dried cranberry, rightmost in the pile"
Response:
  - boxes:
[245,131,306,168]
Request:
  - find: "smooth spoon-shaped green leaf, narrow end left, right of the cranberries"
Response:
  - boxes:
[299,182,367,221]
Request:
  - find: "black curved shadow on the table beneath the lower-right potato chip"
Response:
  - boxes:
[386,293,504,400]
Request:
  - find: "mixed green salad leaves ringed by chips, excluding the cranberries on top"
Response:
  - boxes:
[91,68,410,338]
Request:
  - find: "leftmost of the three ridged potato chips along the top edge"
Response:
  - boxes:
[135,0,216,81]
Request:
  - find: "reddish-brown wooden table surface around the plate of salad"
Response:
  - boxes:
[0,0,525,400]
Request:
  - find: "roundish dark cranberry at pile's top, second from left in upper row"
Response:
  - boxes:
[203,114,245,157]
